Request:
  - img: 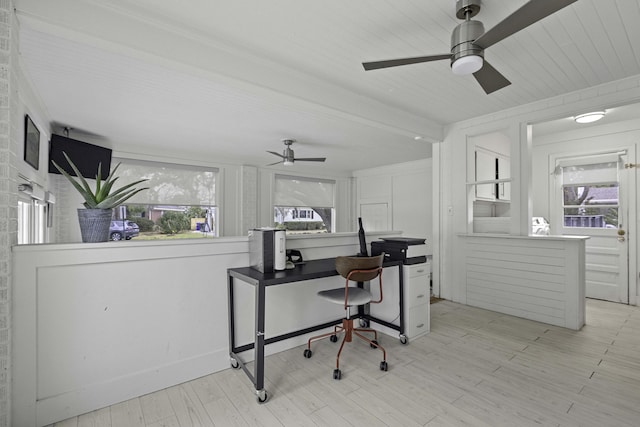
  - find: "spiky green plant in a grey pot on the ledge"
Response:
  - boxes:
[51,152,148,242]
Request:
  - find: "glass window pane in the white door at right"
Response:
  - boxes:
[561,161,620,228]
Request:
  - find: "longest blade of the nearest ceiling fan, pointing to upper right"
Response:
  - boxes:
[473,0,577,49]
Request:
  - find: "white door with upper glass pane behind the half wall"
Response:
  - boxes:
[551,152,633,304]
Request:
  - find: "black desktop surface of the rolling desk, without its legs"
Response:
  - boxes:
[227,258,402,286]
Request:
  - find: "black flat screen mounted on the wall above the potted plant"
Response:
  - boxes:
[49,135,111,179]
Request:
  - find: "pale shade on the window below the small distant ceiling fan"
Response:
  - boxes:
[274,175,336,208]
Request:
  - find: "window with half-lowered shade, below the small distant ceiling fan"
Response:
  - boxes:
[273,175,336,234]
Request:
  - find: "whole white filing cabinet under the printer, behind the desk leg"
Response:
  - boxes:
[369,262,431,339]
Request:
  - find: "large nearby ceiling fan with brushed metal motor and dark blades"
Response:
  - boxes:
[362,0,577,94]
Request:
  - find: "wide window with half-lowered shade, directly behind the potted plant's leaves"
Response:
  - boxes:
[112,159,218,240]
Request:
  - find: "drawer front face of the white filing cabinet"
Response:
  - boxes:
[403,262,431,339]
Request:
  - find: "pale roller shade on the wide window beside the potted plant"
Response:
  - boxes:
[112,159,218,206]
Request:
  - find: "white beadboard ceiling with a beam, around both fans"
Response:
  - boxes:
[16,0,640,171]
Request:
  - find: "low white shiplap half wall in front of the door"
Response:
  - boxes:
[460,235,586,330]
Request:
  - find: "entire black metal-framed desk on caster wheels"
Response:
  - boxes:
[227,258,406,403]
